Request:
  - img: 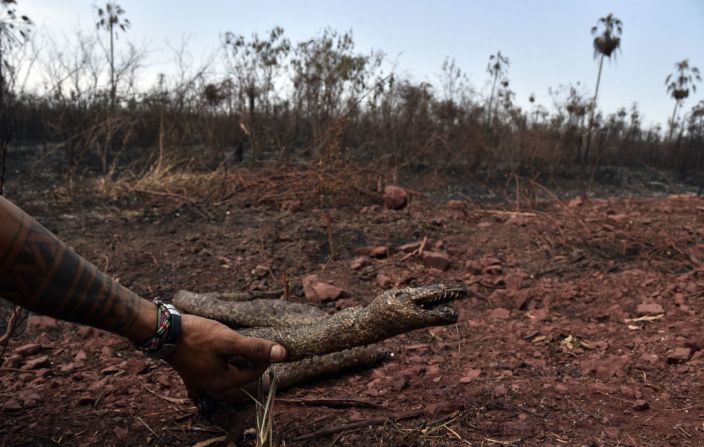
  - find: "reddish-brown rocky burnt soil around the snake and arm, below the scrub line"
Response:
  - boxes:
[0,157,704,446]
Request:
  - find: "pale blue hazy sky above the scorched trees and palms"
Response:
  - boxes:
[18,0,704,127]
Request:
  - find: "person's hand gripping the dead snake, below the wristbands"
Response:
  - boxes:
[166,315,286,401]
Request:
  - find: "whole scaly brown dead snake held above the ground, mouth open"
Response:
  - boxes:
[174,284,466,388]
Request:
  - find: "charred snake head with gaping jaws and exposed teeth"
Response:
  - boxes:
[372,284,467,326]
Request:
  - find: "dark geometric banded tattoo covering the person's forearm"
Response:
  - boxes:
[0,197,143,335]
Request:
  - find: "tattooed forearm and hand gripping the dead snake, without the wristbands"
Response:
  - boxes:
[0,197,286,400]
